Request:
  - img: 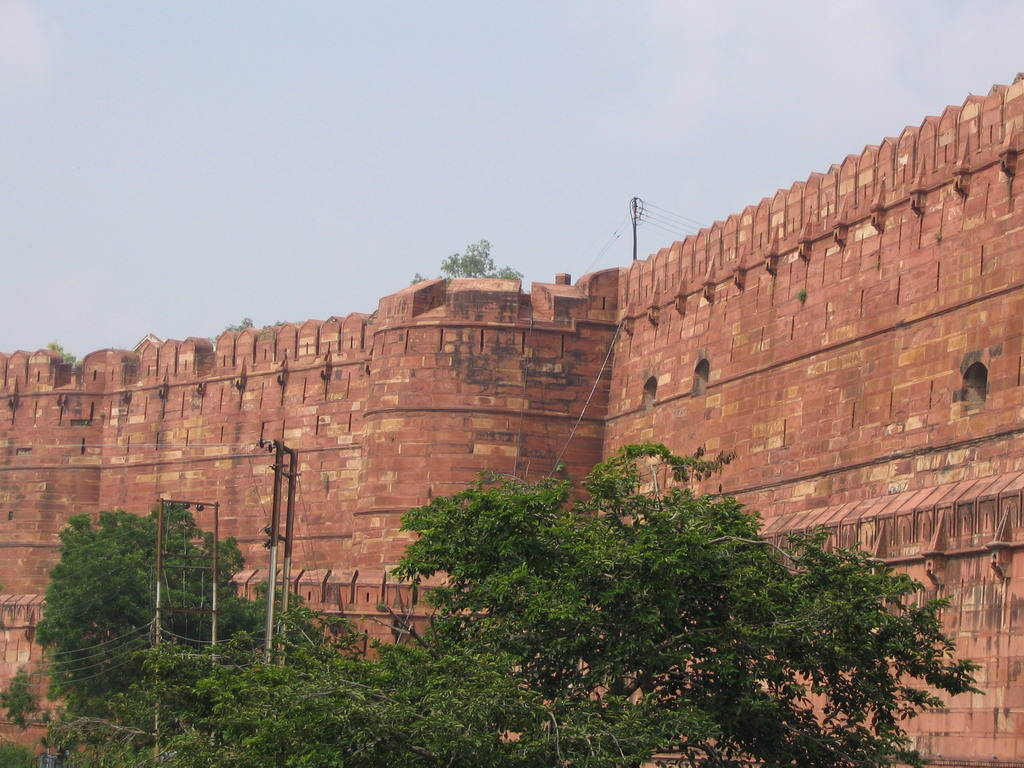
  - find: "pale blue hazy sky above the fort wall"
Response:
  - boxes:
[0,0,1024,356]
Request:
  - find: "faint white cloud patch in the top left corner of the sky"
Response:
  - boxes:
[0,0,54,90]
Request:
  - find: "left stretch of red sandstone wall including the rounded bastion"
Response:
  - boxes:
[0,270,620,607]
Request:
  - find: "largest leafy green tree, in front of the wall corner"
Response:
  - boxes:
[389,444,975,766]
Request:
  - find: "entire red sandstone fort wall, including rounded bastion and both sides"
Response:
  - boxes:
[6,78,1024,765]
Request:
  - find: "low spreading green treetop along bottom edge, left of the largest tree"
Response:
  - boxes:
[70,612,664,768]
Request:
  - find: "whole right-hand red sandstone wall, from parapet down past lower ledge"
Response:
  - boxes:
[605,79,1024,759]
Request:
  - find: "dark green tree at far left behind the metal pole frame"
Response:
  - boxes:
[36,507,260,717]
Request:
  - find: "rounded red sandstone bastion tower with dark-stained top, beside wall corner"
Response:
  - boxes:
[352,269,621,572]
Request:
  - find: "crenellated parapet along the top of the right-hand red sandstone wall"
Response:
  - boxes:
[621,76,1024,317]
